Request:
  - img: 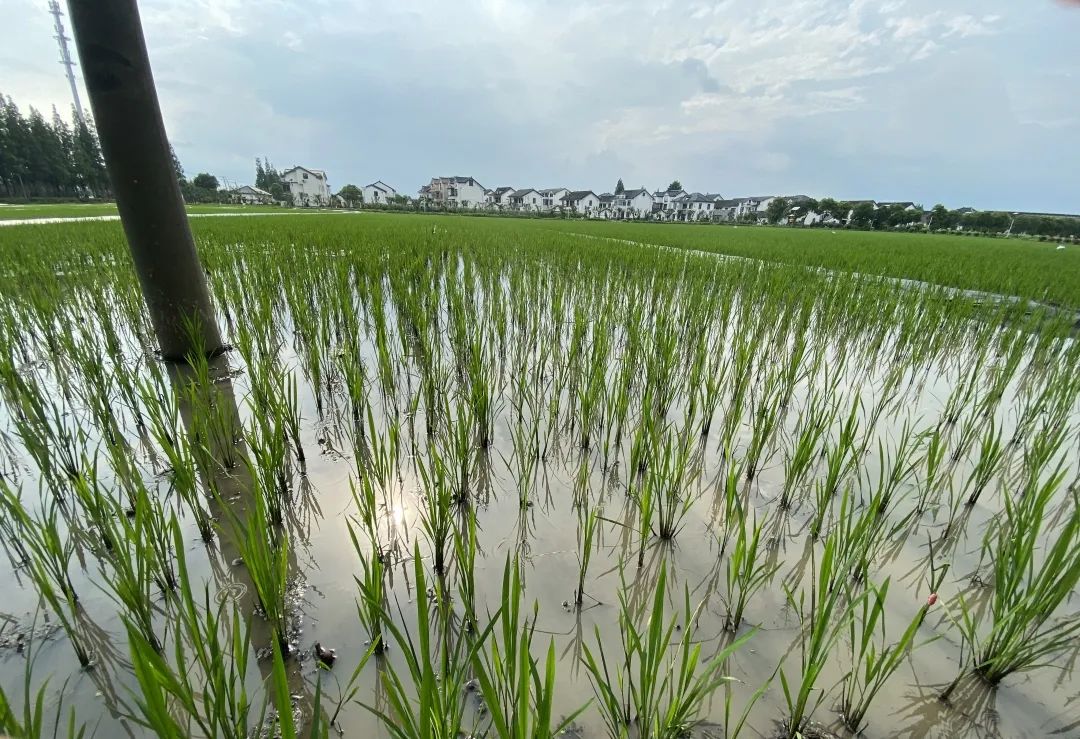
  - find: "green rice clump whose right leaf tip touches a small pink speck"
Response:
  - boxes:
[839,578,935,734]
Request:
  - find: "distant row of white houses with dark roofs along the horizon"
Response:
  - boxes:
[232,166,1080,239]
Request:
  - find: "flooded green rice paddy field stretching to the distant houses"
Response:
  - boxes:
[0,214,1080,739]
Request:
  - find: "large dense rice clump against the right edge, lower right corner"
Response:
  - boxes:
[942,465,1080,699]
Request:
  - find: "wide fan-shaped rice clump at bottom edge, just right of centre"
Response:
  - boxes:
[583,564,753,739]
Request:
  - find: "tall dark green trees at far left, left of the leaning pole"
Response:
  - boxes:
[0,94,110,199]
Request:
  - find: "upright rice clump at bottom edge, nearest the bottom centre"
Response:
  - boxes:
[472,557,588,739]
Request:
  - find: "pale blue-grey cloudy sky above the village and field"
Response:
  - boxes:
[6,0,1080,213]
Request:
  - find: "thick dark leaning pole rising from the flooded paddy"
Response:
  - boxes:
[68,0,225,361]
